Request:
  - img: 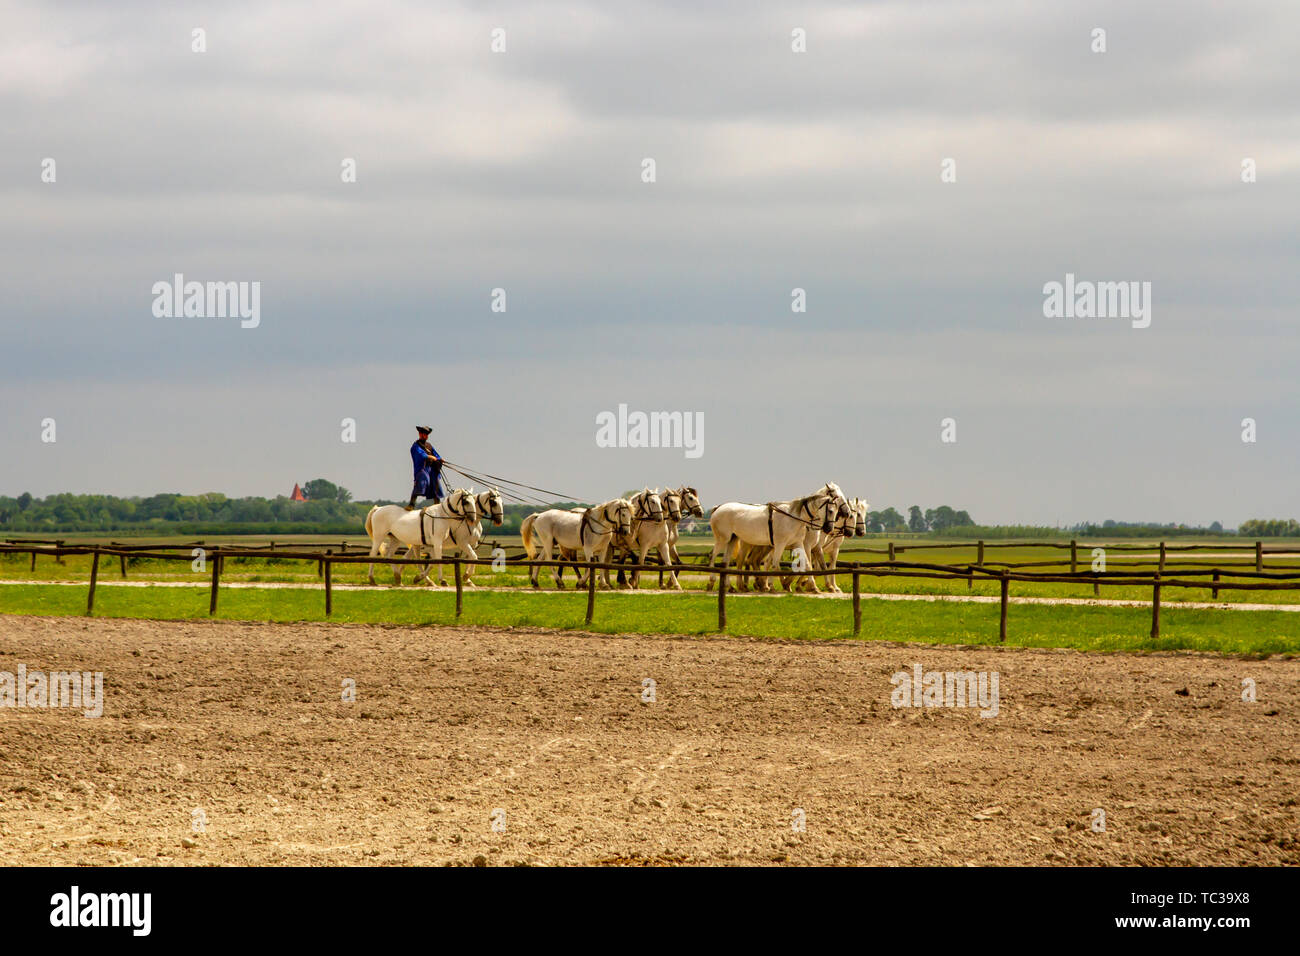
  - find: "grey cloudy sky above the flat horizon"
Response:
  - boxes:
[0,0,1300,525]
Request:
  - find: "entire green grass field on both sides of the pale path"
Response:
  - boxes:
[0,536,1300,654]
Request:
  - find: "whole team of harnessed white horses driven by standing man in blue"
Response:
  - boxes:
[365,481,868,591]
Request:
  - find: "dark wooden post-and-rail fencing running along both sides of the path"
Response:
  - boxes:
[0,540,1300,643]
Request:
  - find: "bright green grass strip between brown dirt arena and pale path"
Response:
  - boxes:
[0,585,1300,656]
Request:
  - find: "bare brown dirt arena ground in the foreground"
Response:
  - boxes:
[0,617,1300,865]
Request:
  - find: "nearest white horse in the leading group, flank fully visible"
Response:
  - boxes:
[709,483,849,591]
